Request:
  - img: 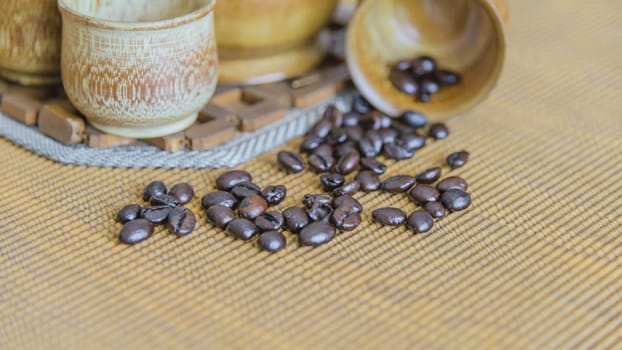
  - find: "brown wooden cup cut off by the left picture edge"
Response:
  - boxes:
[0,0,61,85]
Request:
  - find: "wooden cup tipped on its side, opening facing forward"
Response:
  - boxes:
[346,0,507,120]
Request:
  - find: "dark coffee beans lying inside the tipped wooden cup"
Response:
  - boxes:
[389,56,461,103]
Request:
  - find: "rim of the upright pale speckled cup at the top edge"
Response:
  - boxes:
[58,0,216,31]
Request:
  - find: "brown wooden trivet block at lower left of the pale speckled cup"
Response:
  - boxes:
[39,104,86,144]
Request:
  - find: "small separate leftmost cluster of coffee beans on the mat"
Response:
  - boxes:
[117,181,196,244]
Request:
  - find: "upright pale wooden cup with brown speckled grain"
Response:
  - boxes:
[58,0,218,138]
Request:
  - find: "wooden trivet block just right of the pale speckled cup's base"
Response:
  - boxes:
[186,119,237,151]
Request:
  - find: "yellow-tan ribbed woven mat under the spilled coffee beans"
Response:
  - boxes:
[0,0,622,349]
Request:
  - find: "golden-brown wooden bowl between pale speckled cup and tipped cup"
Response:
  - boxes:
[216,0,338,84]
